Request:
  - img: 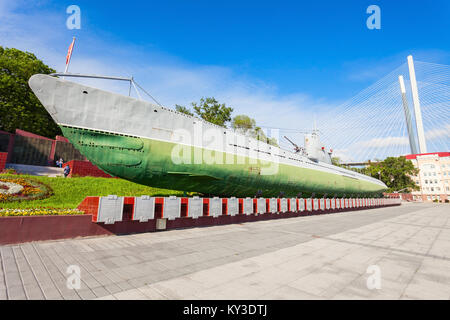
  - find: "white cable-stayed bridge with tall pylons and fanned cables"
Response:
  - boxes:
[280,56,450,163]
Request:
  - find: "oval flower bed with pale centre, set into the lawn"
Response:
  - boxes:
[0,177,53,202]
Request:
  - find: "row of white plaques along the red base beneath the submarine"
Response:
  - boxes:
[97,195,400,224]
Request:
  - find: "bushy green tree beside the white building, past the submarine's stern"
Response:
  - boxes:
[365,156,419,192]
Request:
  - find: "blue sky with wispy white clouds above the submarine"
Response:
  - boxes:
[0,0,450,158]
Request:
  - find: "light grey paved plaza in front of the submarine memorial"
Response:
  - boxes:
[0,203,450,299]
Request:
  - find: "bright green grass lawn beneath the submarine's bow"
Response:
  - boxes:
[0,174,183,209]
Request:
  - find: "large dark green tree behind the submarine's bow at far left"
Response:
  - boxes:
[0,46,61,138]
